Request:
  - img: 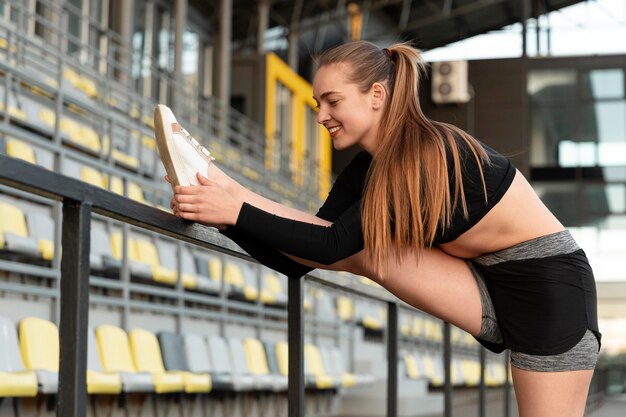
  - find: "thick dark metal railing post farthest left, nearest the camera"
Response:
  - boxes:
[57,200,91,417]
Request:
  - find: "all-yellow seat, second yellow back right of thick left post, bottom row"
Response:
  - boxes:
[128,329,184,394]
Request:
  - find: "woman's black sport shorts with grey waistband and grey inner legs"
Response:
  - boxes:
[468,231,601,372]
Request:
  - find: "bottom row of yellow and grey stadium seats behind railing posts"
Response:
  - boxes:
[0,317,373,397]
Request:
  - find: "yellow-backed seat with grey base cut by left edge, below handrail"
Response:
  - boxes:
[0,201,40,258]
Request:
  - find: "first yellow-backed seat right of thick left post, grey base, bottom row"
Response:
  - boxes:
[96,324,154,392]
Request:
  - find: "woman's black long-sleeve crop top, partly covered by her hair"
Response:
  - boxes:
[227,136,515,276]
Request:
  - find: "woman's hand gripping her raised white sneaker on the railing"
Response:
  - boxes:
[171,171,243,230]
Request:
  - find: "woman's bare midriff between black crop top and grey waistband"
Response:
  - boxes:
[439,171,564,259]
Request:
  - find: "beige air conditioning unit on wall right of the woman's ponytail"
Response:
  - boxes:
[431,61,470,104]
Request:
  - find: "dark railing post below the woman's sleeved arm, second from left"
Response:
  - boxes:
[287,278,304,417]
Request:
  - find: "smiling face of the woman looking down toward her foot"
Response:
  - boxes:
[313,64,385,153]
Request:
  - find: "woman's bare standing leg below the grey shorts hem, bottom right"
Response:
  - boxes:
[511,366,593,417]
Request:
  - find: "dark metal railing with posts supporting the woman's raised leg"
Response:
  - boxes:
[0,155,509,417]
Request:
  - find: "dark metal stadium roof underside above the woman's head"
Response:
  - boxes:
[190,0,581,53]
